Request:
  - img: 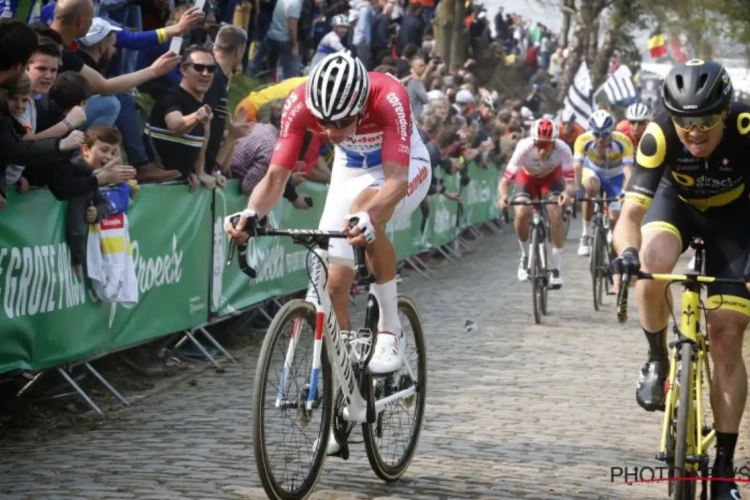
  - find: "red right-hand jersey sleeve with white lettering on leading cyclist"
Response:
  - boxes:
[378,75,413,167]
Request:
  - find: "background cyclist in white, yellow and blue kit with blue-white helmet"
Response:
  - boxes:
[573,109,633,256]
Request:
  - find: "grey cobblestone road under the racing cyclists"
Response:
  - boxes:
[0,227,746,500]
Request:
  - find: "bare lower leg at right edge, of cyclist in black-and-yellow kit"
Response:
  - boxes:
[707,309,750,434]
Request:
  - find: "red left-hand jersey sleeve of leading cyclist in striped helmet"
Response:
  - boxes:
[271,85,318,170]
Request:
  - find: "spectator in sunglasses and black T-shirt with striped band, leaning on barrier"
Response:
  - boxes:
[144,46,217,191]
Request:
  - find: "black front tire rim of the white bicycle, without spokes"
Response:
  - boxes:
[252,299,333,500]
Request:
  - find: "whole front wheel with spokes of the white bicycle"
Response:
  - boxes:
[252,300,333,500]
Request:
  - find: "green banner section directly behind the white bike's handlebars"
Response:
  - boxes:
[211,180,327,316]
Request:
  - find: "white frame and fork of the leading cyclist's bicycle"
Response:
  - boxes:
[276,248,417,423]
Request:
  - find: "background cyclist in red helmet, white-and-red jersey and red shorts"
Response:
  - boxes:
[498,118,574,289]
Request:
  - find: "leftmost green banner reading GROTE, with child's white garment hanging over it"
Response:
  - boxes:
[0,185,212,372]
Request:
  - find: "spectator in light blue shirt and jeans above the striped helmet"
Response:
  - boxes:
[265,0,302,82]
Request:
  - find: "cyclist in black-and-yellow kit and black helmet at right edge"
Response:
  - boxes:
[613,60,750,500]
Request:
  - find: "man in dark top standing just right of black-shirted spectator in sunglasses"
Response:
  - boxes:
[203,26,253,179]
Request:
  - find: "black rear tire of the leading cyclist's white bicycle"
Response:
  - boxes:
[362,295,427,483]
